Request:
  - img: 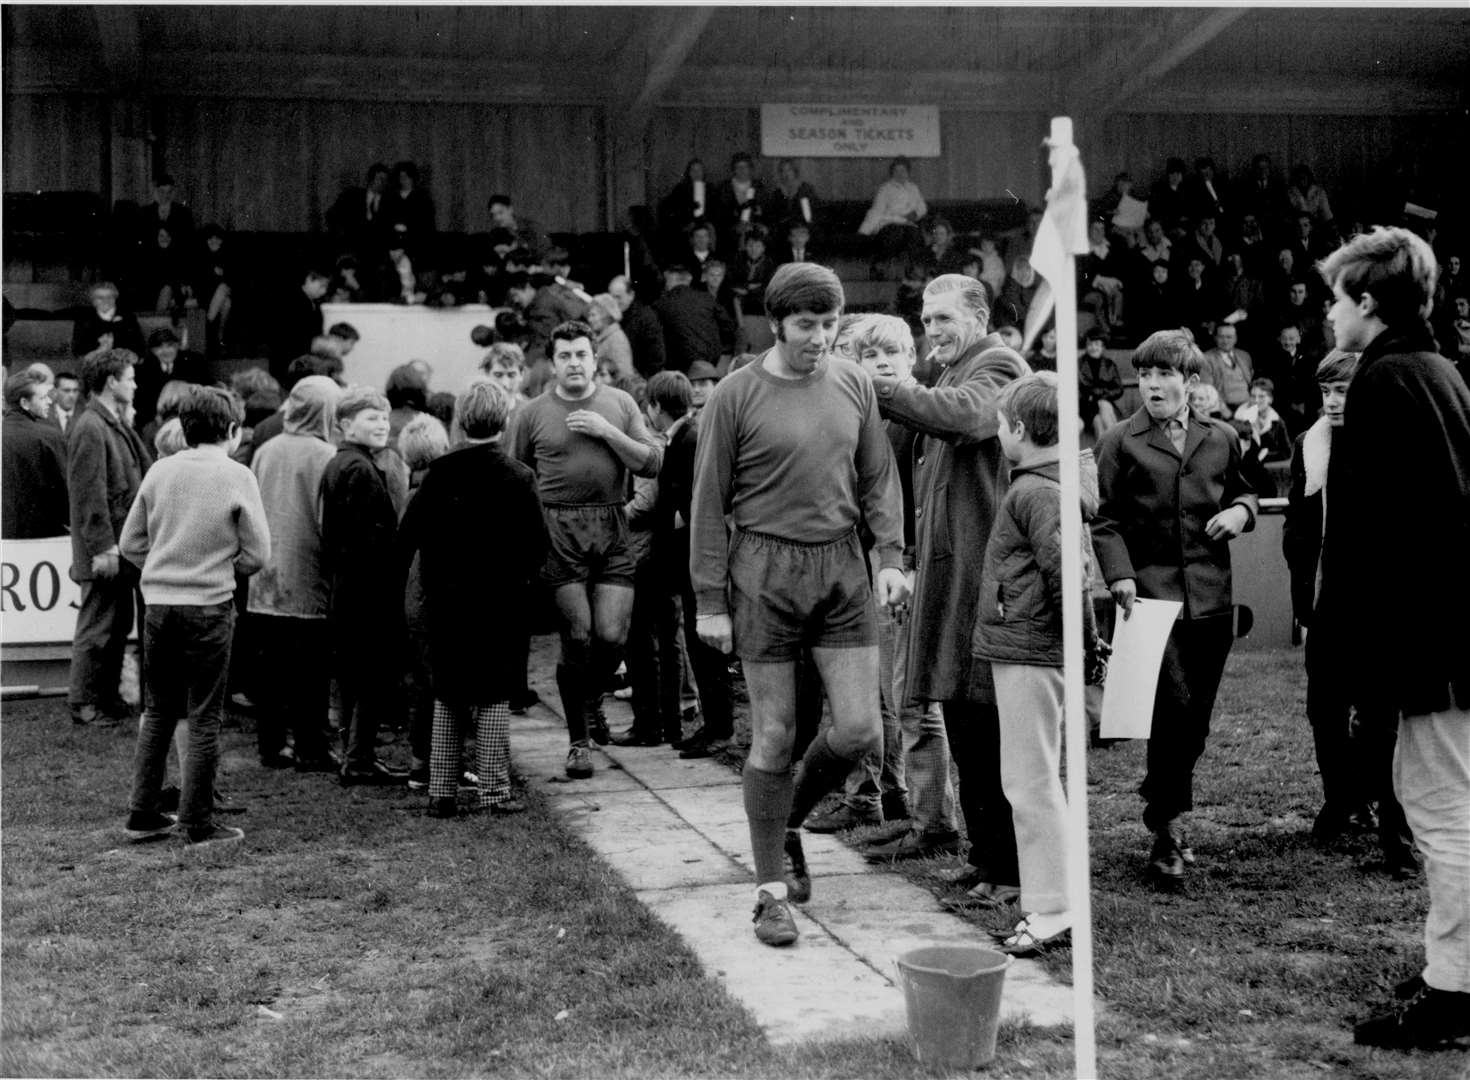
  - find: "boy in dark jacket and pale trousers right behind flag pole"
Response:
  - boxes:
[973,372,1097,955]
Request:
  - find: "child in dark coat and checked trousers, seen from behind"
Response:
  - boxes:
[398,382,548,818]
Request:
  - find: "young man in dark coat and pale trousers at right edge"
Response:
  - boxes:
[1313,228,1470,1049]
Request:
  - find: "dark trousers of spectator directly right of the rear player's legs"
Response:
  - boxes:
[628,560,684,742]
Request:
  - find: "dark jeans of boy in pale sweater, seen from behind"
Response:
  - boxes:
[131,601,235,829]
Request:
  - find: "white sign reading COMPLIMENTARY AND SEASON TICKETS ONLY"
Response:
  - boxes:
[760,104,939,157]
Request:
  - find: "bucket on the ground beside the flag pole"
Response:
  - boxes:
[897,945,1011,1068]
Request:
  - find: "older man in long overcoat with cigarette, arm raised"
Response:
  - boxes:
[873,273,1029,901]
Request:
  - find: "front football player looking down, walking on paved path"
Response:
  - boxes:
[689,263,908,945]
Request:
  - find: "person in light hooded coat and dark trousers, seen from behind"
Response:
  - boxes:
[245,376,343,773]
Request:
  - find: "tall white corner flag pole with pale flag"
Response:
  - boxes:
[1028,116,1098,1080]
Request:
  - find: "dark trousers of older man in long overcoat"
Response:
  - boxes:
[944,701,1020,885]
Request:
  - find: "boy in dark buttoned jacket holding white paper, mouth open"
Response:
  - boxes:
[1092,331,1257,889]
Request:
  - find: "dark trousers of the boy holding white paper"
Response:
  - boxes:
[1139,613,1235,832]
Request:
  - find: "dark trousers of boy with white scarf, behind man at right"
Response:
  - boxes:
[1305,627,1411,843]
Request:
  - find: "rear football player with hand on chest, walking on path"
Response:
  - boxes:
[509,322,663,780]
